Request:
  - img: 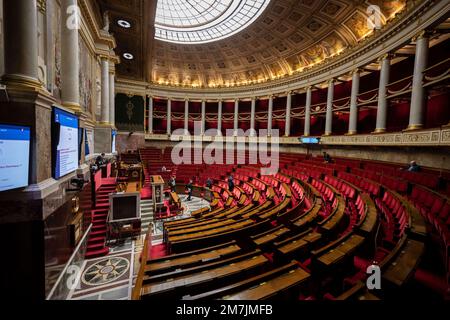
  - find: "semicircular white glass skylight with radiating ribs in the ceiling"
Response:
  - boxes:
[155,0,270,43]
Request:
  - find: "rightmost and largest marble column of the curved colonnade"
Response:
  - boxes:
[408,32,430,130]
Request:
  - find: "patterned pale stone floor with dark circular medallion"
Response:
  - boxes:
[67,194,209,300]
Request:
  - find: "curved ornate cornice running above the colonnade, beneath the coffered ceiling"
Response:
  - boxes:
[121,0,450,99]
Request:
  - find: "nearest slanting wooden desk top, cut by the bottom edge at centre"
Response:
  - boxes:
[223,268,311,300]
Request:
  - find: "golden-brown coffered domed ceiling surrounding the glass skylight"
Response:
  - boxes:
[98,0,407,87]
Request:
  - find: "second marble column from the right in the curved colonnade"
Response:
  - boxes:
[375,54,392,133]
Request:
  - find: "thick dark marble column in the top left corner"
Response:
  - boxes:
[3,0,41,87]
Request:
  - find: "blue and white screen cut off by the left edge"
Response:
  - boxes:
[0,124,31,191]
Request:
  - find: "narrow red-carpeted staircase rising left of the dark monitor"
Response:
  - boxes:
[85,184,116,259]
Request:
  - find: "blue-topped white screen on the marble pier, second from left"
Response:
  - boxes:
[52,108,79,179]
